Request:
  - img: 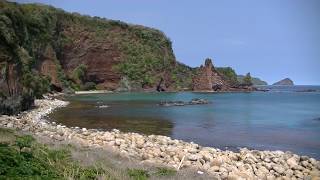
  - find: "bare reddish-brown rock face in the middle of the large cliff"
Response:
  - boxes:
[61,25,121,90]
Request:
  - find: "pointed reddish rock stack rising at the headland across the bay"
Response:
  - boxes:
[192,58,229,91]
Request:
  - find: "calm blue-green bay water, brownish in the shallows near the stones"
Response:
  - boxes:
[51,86,320,159]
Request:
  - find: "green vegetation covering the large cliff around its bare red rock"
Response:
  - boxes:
[0,1,185,100]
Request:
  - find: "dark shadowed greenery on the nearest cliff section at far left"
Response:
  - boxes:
[0,1,61,97]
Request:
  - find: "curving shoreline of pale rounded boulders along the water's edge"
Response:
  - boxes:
[0,97,320,179]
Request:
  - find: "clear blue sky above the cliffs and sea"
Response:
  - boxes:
[16,0,320,85]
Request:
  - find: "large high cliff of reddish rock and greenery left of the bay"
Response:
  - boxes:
[0,1,185,98]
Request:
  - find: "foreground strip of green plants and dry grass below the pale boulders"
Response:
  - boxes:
[0,128,176,180]
